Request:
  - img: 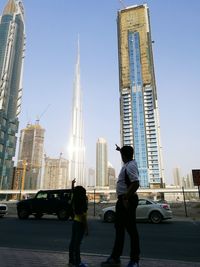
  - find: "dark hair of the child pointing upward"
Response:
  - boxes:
[73,185,88,214]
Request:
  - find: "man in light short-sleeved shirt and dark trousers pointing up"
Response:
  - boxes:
[101,145,140,267]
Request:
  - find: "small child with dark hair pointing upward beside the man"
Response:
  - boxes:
[68,179,88,267]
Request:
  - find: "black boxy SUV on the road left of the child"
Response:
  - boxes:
[17,189,73,220]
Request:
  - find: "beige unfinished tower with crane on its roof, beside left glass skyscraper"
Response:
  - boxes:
[17,122,45,190]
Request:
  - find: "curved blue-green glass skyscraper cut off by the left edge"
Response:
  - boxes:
[0,0,25,189]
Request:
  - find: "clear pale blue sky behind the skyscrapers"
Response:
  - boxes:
[0,0,200,183]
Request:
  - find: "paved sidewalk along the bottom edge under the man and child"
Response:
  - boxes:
[0,248,200,267]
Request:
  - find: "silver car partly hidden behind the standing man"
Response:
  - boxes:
[99,198,172,223]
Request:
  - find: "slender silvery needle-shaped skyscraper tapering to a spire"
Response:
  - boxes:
[69,40,85,186]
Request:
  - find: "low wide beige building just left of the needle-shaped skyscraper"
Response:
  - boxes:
[42,156,71,189]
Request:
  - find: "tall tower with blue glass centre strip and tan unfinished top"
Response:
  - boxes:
[117,4,164,187]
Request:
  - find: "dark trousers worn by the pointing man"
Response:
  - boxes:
[111,194,140,262]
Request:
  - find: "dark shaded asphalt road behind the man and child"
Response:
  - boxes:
[0,216,200,262]
